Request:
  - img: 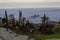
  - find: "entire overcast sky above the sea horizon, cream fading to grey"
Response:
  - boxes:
[0,0,60,9]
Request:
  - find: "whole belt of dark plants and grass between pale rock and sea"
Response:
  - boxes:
[0,11,60,40]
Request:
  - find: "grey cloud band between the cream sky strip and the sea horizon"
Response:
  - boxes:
[0,2,60,9]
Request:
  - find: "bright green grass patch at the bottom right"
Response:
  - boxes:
[33,34,60,40]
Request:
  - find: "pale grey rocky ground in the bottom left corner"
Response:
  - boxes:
[0,28,28,40]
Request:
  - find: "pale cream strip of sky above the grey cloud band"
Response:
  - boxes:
[0,0,60,3]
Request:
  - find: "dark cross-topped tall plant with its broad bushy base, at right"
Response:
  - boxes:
[39,14,53,34]
